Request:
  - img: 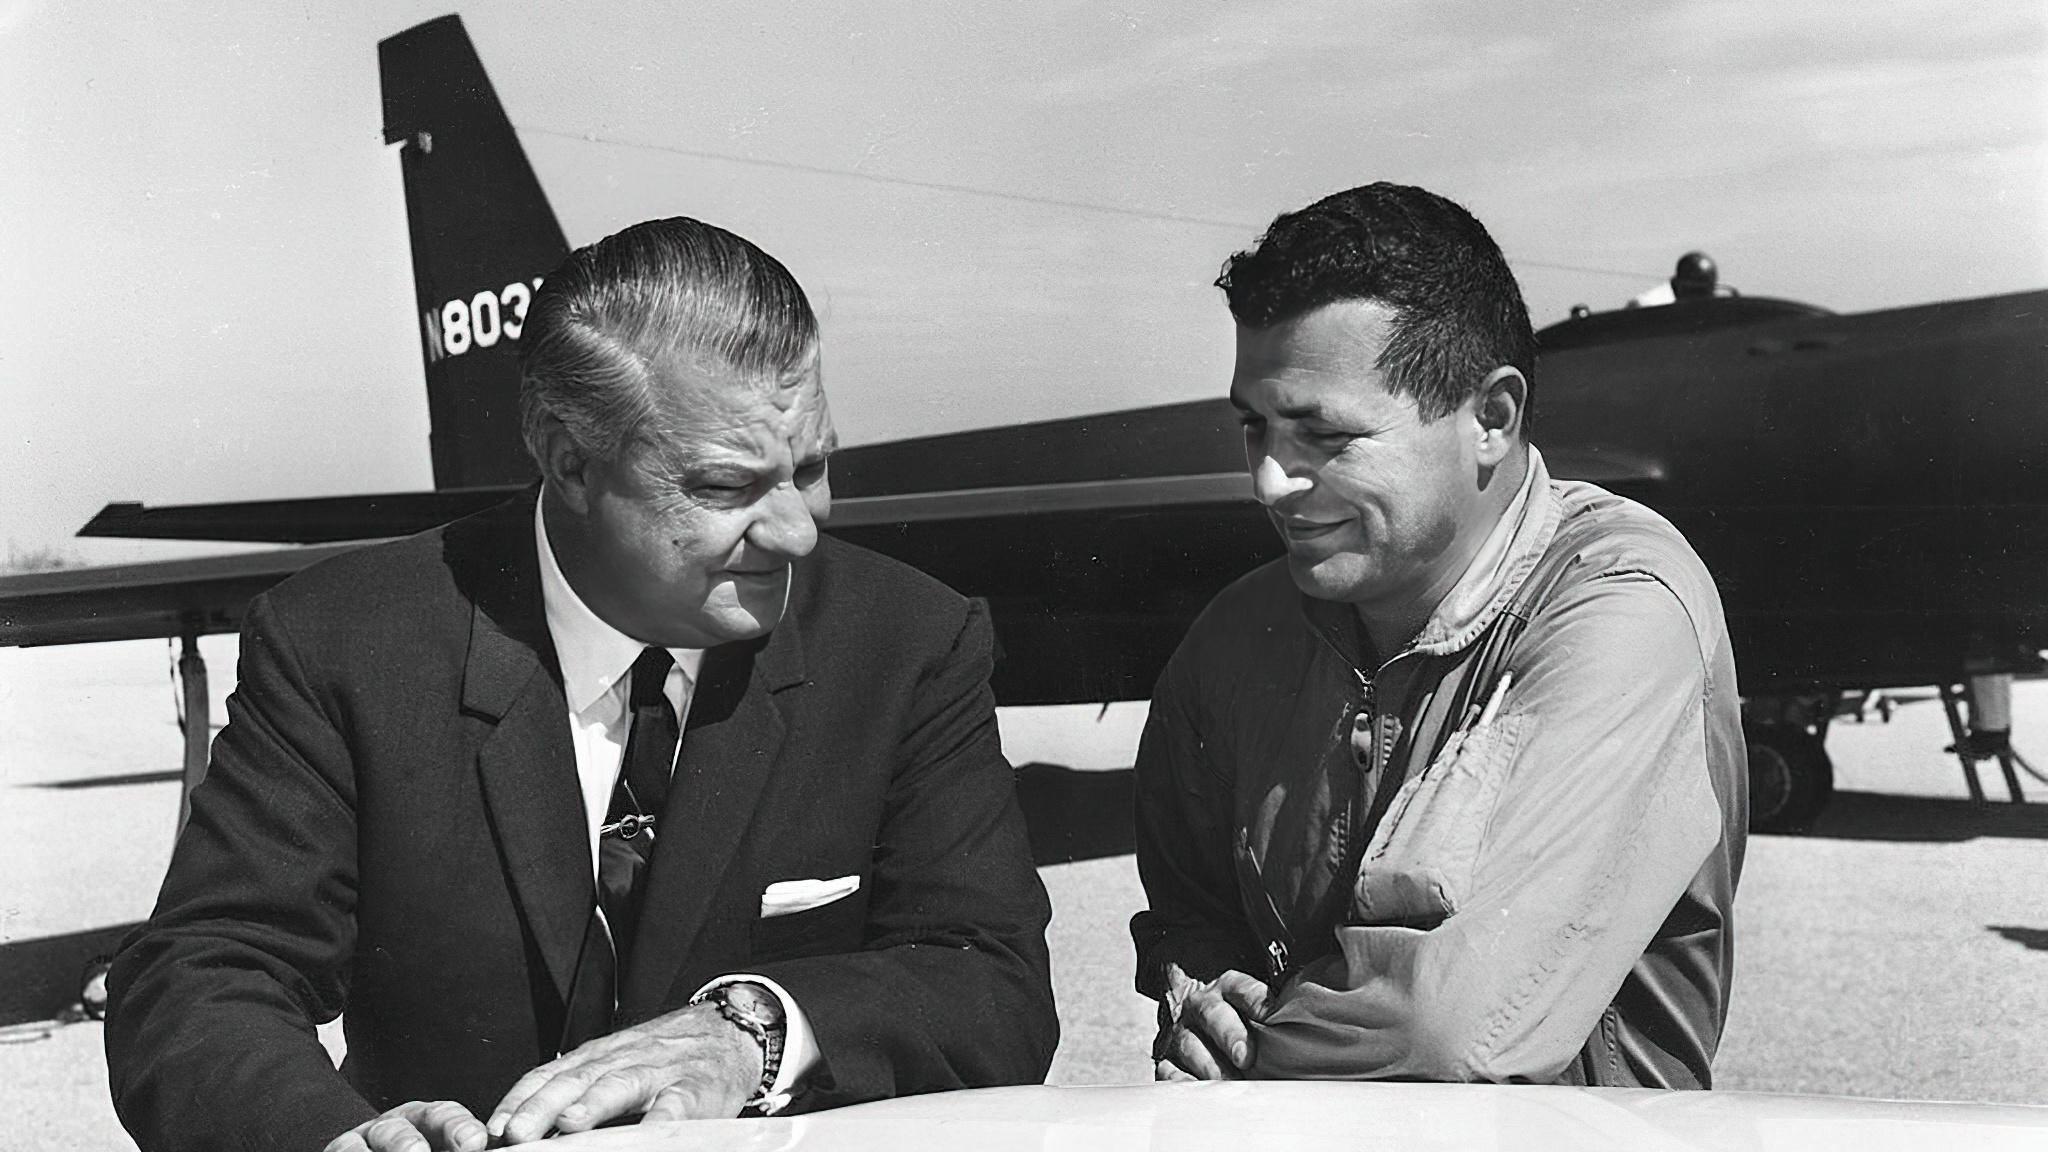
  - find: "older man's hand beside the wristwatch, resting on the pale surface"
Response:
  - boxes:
[489,1004,762,1144]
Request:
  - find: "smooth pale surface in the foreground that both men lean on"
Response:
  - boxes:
[555,1080,2048,1152]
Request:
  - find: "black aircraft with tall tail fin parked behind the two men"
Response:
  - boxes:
[0,16,2048,828]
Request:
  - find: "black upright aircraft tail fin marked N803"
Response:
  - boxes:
[377,16,569,488]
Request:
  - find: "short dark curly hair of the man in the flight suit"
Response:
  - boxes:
[1217,182,1536,424]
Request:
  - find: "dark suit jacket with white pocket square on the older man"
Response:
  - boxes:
[106,496,1059,1150]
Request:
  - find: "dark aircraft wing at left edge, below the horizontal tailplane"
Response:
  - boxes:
[0,541,371,646]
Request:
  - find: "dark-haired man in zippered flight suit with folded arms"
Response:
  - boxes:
[1130,184,1747,1088]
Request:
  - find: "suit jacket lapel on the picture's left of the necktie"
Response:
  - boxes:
[446,498,596,998]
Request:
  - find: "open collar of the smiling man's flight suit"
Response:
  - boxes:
[1300,445,1565,672]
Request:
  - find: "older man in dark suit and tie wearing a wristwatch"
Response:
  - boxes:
[106,219,1057,1150]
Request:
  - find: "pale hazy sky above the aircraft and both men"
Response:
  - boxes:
[0,0,2048,562]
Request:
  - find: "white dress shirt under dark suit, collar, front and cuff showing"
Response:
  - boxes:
[532,496,819,1113]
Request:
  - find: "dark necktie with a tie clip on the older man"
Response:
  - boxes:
[561,648,682,1052]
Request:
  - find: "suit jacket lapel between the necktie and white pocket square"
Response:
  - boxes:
[618,611,805,1008]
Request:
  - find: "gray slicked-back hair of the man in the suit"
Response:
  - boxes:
[518,215,817,463]
